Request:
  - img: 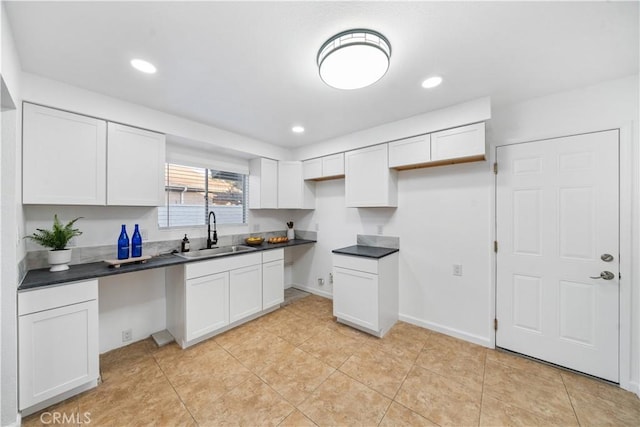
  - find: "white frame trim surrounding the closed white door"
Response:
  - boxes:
[488,122,640,395]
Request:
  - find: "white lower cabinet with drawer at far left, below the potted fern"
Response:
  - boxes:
[18,280,99,415]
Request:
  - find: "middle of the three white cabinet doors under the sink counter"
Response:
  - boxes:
[229,264,262,323]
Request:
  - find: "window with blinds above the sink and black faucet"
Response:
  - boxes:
[158,163,247,227]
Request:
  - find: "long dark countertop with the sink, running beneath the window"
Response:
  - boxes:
[18,239,315,291]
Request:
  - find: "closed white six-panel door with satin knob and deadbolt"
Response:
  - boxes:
[496,130,619,382]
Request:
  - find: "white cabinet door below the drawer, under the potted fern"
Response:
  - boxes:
[18,300,99,410]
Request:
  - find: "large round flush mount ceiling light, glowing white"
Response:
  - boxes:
[317,29,391,90]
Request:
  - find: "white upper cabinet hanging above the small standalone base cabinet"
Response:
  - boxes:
[345,144,398,208]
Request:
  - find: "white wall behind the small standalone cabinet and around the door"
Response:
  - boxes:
[292,76,640,391]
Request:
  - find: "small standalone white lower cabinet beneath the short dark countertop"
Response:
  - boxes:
[333,252,398,337]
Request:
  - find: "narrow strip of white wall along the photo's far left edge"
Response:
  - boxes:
[0,3,24,426]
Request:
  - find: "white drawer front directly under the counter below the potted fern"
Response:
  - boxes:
[18,280,98,316]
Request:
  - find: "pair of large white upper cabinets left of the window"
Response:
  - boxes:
[22,103,165,206]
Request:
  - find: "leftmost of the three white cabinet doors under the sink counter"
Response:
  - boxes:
[186,272,229,341]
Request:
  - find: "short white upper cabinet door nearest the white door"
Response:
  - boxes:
[431,123,485,161]
